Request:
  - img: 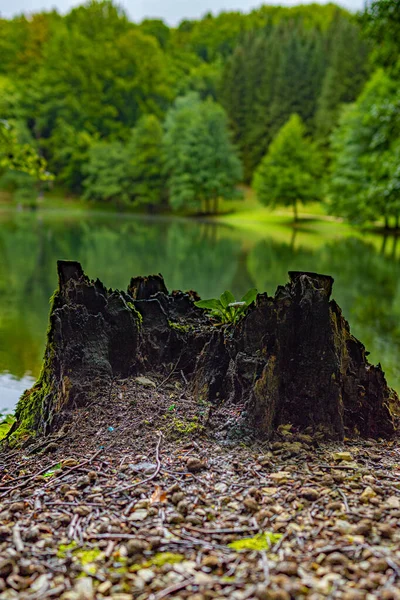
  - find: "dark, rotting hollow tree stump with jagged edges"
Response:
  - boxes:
[16,261,398,439]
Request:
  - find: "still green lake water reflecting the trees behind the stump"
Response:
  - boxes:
[0,207,400,410]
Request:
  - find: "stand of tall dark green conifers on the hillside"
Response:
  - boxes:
[218,5,368,181]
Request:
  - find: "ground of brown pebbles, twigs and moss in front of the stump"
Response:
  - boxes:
[0,374,400,600]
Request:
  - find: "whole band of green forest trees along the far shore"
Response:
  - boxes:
[0,0,400,228]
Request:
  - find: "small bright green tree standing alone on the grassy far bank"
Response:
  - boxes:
[253,115,321,219]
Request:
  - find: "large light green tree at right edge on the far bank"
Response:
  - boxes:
[329,70,400,224]
